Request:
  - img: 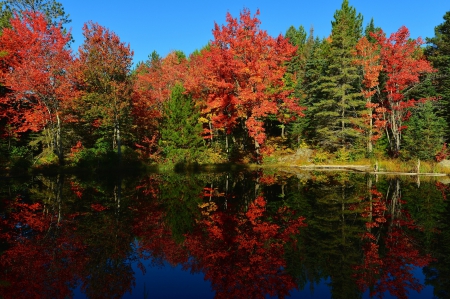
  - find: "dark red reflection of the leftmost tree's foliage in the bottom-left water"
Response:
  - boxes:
[0,198,86,298]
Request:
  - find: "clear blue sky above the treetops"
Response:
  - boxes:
[59,0,450,63]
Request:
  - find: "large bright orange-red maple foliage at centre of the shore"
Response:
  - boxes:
[185,10,304,149]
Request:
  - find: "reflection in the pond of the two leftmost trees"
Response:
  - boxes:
[0,175,139,298]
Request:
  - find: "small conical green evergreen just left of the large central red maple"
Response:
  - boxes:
[161,83,203,163]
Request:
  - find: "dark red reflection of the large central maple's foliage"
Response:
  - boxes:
[186,196,304,298]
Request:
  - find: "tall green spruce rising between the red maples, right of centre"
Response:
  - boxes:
[311,0,365,151]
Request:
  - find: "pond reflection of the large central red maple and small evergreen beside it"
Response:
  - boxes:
[137,173,303,298]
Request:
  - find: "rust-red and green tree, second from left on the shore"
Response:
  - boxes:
[72,22,133,152]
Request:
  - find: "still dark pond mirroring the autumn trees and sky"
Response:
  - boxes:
[0,171,450,299]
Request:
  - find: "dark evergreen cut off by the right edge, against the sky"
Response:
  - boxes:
[425,11,450,138]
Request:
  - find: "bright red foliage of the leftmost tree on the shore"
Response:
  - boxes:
[0,12,76,132]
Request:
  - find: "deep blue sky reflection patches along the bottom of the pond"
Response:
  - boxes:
[74,261,433,299]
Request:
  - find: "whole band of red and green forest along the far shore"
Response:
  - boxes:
[0,0,450,170]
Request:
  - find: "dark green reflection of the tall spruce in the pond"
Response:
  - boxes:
[286,173,365,298]
